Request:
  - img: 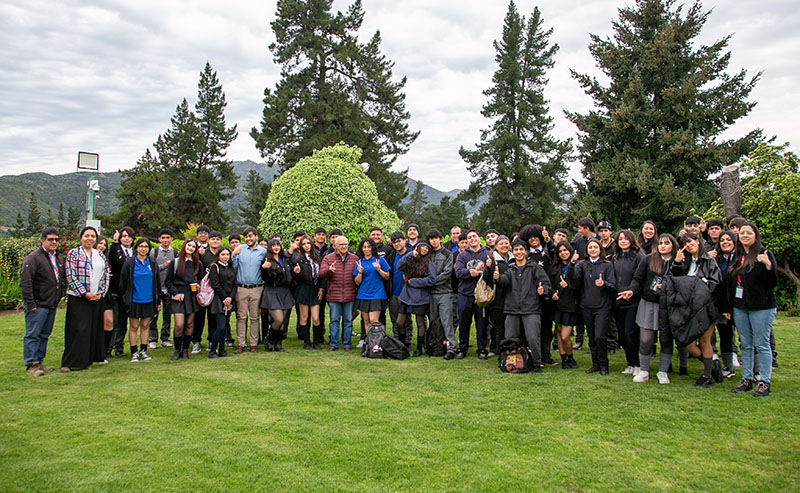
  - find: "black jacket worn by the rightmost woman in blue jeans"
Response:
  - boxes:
[728,248,778,310]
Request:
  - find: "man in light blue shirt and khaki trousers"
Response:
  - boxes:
[233,226,267,354]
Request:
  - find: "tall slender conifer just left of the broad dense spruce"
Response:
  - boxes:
[459,1,571,232]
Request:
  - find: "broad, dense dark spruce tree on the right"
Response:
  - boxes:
[567,0,762,231]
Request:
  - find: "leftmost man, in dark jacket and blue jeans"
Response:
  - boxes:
[19,228,66,377]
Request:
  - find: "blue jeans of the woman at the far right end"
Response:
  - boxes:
[733,308,777,383]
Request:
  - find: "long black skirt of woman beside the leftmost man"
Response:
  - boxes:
[61,295,105,368]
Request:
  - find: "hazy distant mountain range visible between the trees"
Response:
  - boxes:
[0,160,480,226]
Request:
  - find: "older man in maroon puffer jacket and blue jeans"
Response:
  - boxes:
[319,236,357,352]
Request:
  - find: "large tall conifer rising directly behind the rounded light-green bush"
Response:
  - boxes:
[250,0,419,208]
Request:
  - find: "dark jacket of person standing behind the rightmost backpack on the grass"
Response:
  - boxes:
[492,261,553,315]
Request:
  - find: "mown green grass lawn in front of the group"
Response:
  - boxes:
[0,311,800,491]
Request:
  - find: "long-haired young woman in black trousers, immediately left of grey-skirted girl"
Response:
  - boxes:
[614,229,645,375]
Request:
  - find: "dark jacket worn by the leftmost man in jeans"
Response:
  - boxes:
[19,246,67,309]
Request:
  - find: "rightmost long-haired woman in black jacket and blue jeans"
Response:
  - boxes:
[728,222,778,397]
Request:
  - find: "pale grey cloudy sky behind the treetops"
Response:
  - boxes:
[0,0,800,190]
